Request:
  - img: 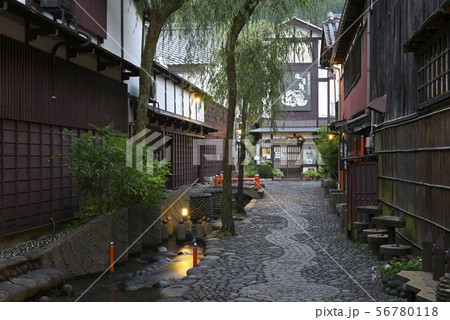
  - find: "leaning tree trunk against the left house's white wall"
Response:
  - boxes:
[134,0,189,134]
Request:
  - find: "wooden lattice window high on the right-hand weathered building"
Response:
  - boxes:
[417,24,450,109]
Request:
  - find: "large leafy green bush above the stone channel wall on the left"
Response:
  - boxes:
[58,125,170,225]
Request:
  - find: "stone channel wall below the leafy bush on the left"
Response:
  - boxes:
[39,205,161,278]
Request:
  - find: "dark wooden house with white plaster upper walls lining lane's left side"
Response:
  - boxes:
[0,0,225,239]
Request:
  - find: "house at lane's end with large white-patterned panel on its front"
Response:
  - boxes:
[250,17,336,178]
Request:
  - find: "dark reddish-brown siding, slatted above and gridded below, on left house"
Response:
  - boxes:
[0,36,128,237]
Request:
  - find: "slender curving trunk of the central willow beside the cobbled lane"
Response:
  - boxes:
[220,0,259,235]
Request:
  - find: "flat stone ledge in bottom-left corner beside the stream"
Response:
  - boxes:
[0,269,63,302]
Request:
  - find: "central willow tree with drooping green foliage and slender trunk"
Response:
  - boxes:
[174,0,323,234]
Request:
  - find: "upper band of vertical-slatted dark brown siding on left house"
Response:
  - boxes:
[0,36,128,132]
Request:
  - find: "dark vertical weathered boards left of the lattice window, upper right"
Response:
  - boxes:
[371,0,444,120]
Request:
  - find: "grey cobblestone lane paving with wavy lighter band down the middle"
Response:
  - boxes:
[169,181,405,301]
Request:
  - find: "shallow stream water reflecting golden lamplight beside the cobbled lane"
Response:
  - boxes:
[52,239,202,302]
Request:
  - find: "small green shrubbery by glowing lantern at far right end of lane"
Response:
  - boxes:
[314,127,339,180]
